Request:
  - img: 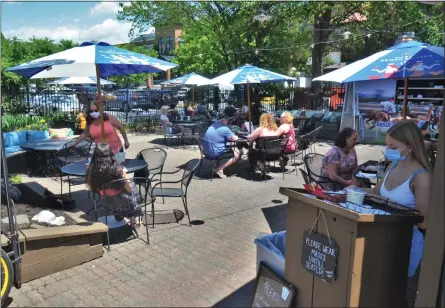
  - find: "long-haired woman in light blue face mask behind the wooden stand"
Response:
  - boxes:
[346,121,432,304]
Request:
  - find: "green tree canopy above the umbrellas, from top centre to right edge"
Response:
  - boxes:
[118,1,444,77]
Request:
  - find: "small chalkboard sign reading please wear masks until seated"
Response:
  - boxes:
[301,231,338,283]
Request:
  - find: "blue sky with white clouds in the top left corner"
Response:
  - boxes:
[1,0,148,44]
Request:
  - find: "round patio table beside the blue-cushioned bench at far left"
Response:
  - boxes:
[20,139,72,176]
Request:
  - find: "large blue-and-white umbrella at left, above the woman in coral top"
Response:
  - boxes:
[6,41,177,139]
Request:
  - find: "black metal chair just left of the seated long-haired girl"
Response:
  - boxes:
[54,140,92,198]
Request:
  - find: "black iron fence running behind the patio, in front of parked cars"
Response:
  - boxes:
[1,85,344,123]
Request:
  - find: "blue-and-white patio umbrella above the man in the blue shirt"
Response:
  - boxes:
[201,64,296,132]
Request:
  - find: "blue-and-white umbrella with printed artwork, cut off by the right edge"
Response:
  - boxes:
[313,40,444,116]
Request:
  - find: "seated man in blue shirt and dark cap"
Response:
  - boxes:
[203,113,239,178]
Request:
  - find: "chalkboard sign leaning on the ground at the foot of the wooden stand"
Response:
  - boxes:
[252,262,295,307]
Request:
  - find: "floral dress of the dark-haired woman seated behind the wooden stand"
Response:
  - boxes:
[320,146,357,189]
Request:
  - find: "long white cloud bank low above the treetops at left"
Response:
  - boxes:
[3,18,131,44]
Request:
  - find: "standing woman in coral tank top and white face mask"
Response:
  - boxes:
[72,102,130,153]
